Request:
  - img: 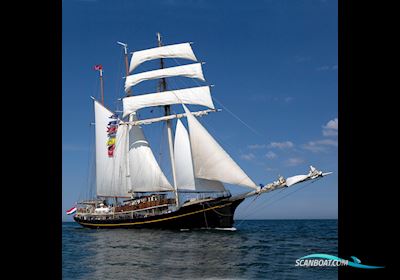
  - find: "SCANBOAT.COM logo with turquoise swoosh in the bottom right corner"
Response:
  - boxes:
[295,254,384,269]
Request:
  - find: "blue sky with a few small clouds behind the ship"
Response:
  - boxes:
[62,0,338,220]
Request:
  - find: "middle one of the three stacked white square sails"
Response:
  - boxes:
[125,63,205,92]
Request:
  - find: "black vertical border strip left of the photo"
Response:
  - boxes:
[11,0,62,279]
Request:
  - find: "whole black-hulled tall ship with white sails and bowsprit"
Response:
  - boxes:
[72,33,330,229]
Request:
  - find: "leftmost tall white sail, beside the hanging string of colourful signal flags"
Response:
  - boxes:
[94,101,129,196]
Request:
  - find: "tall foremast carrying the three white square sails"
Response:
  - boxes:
[157,32,179,207]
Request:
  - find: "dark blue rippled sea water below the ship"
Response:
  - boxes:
[62,220,338,280]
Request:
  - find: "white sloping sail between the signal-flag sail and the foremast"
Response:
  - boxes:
[129,115,174,192]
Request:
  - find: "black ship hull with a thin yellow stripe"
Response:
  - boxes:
[74,198,244,229]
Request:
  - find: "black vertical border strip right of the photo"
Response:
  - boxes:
[338,0,390,279]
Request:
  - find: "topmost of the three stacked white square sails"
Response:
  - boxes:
[129,43,197,73]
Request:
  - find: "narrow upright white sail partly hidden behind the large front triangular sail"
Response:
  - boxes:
[174,119,225,192]
